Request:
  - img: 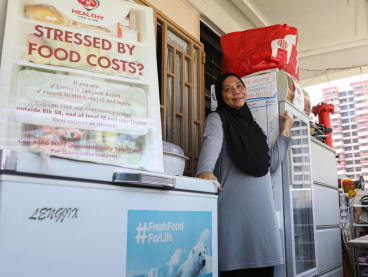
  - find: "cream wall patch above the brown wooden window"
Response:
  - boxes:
[148,0,200,40]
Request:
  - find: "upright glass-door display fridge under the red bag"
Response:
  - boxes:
[242,69,317,277]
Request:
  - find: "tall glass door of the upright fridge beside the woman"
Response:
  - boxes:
[279,102,317,276]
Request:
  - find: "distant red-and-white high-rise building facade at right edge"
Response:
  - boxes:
[323,81,368,180]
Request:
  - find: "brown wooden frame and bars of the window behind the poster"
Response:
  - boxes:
[135,0,205,176]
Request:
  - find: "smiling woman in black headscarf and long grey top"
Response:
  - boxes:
[197,73,293,277]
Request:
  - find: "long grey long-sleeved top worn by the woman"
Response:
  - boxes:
[197,113,291,271]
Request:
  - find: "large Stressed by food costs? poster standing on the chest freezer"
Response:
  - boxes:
[0,0,163,172]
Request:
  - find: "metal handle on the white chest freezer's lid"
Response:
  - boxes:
[112,172,175,189]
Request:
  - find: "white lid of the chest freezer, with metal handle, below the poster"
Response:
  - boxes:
[0,149,218,194]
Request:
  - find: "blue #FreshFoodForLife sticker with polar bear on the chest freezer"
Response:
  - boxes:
[126,210,212,277]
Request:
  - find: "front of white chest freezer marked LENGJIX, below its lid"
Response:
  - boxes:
[0,175,218,277]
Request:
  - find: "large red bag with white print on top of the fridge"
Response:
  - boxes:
[221,24,299,80]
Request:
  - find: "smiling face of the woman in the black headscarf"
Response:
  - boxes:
[222,76,248,109]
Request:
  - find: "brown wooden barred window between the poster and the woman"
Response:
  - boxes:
[136,0,204,176]
